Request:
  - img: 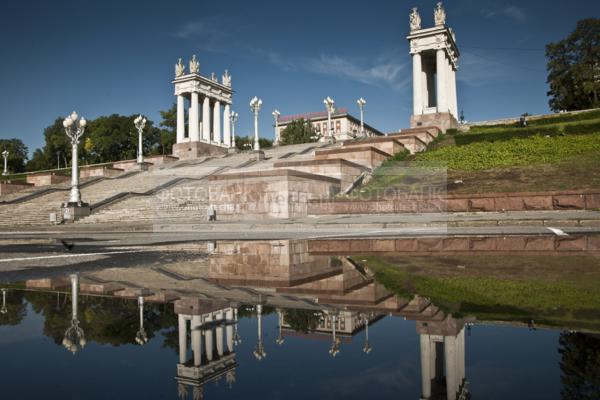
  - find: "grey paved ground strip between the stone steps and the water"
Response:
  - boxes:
[0,211,600,282]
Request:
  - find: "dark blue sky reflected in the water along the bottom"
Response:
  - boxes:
[0,302,560,400]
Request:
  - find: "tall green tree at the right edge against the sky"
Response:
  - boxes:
[546,18,600,111]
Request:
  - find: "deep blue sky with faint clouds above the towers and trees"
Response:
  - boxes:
[0,0,600,152]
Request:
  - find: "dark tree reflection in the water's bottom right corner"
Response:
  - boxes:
[558,332,600,400]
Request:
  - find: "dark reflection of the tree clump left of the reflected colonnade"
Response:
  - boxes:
[25,292,177,348]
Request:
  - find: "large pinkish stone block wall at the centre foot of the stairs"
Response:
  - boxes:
[209,169,340,220]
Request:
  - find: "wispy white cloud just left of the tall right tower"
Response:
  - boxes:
[307,55,410,91]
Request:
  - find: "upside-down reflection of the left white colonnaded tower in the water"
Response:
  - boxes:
[175,299,237,400]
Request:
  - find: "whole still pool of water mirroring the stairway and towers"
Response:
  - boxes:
[0,236,600,399]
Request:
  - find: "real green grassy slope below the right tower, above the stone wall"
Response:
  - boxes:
[361,112,600,194]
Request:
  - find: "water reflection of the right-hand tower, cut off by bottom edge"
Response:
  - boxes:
[417,317,470,400]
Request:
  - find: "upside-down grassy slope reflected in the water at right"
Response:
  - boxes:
[356,256,600,330]
